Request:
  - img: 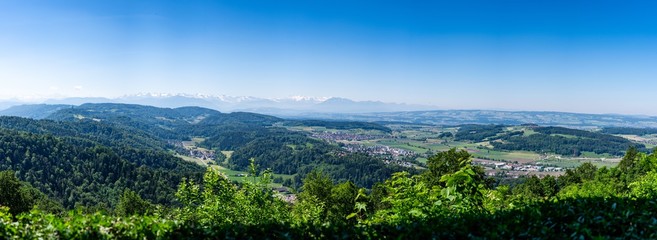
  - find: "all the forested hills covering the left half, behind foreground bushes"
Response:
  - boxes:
[0,104,416,209]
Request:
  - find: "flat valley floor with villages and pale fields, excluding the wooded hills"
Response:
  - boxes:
[288,123,632,178]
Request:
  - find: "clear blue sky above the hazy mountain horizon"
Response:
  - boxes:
[0,0,657,115]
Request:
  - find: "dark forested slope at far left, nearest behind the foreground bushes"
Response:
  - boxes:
[0,127,203,208]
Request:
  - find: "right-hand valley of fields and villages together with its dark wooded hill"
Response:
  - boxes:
[289,123,653,168]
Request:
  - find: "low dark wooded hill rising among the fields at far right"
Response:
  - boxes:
[491,127,648,156]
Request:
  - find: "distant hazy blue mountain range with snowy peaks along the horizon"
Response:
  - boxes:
[0,93,657,128]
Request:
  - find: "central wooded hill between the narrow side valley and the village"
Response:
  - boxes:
[220,128,407,188]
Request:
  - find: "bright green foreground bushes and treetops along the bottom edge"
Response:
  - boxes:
[0,148,657,239]
